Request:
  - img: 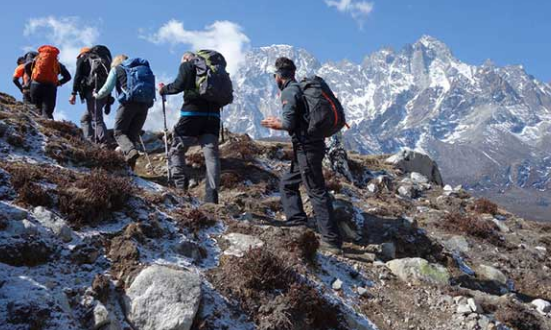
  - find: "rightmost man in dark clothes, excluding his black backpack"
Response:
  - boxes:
[261,57,342,254]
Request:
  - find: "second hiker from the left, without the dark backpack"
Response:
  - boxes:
[69,47,110,143]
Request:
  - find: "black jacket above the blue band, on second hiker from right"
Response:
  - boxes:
[160,62,220,114]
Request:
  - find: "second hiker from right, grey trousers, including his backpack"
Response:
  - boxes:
[159,51,233,204]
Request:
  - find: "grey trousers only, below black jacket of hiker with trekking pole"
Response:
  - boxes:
[170,134,220,204]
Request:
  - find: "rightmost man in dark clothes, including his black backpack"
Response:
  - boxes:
[261,57,344,254]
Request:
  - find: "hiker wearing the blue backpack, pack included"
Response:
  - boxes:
[93,55,155,169]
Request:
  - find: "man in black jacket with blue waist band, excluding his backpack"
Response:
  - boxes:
[159,52,220,204]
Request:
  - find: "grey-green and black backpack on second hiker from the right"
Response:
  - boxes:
[194,50,233,107]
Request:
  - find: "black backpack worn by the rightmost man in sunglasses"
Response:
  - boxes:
[300,76,346,138]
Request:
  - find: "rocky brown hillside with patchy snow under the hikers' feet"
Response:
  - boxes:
[0,94,551,330]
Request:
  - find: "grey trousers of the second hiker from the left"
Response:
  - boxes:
[80,91,107,143]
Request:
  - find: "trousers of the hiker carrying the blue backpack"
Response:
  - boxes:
[114,102,149,160]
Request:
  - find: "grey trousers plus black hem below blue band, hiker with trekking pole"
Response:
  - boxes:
[169,116,221,204]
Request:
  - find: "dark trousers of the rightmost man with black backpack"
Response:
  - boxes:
[280,141,342,247]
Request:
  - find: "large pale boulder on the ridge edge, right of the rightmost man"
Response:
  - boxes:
[386,149,444,186]
